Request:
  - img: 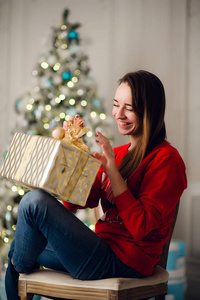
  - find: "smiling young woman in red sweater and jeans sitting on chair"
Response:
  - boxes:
[6,71,187,300]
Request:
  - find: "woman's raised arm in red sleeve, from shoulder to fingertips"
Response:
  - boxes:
[94,134,187,240]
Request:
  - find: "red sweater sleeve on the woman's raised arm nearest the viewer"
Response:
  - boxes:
[115,147,187,240]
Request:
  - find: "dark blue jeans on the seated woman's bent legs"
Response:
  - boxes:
[5,190,144,300]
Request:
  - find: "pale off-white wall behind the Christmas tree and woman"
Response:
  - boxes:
[0,0,200,276]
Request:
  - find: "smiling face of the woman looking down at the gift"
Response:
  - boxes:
[112,82,142,138]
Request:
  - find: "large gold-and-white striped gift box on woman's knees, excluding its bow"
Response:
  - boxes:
[0,133,100,206]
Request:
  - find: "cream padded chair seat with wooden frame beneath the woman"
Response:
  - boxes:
[19,266,169,300]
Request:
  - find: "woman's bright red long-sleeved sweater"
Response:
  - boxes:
[64,142,187,276]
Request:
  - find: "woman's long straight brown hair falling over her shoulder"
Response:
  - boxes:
[118,70,166,179]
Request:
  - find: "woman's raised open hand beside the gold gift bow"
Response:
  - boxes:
[93,132,117,177]
